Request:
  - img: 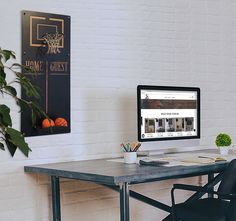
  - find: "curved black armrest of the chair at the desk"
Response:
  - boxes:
[172,184,236,200]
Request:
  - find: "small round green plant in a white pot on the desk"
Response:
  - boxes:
[215,133,232,155]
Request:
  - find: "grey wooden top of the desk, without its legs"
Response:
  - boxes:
[24,150,228,185]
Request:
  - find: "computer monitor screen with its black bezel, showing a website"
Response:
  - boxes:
[137,85,200,142]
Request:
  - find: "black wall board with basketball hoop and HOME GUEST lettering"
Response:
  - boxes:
[21,11,70,136]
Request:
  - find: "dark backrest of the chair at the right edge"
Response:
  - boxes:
[218,159,236,194]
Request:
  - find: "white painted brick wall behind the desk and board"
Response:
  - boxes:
[0,0,236,221]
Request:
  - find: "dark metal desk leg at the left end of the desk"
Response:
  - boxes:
[51,176,61,221]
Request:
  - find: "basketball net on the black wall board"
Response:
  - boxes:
[43,32,64,54]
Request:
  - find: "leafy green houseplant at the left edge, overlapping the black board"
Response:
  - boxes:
[0,48,45,157]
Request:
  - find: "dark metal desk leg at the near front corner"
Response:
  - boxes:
[120,183,129,221]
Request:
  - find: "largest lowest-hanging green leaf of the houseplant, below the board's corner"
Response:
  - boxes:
[6,127,31,157]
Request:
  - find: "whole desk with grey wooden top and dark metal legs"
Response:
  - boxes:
[24,151,228,221]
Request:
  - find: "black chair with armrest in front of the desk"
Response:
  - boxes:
[171,159,236,221]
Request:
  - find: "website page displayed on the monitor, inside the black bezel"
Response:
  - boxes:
[141,90,198,139]
